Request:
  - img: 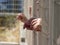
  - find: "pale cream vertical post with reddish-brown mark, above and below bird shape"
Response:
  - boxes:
[24,0,34,45]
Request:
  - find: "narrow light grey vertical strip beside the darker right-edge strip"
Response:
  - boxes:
[48,0,54,45]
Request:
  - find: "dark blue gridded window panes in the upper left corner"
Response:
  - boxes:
[0,0,23,13]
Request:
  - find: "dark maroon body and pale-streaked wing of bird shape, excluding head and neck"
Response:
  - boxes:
[24,18,42,31]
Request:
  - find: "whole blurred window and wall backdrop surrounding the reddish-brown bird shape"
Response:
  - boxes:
[0,0,60,45]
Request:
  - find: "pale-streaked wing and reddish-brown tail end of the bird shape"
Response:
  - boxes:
[30,18,42,31]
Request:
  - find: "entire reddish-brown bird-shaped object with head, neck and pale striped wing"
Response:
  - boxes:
[17,13,42,31]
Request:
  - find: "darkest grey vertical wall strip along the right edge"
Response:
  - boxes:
[54,0,60,45]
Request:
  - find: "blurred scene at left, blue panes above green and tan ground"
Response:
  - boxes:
[0,0,23,43]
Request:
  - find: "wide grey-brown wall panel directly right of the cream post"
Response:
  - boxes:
[33,0,49,45]
